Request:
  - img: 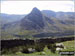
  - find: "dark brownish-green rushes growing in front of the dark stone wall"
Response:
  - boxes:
[1,43,55,54]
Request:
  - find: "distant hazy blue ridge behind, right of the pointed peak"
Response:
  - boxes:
[42,10,75,20]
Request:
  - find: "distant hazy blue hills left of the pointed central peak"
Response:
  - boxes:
[0,13,25,24]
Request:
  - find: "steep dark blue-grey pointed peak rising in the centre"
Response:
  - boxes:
[21,8,44,30]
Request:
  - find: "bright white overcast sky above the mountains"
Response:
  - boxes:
[1,1,74,14]
